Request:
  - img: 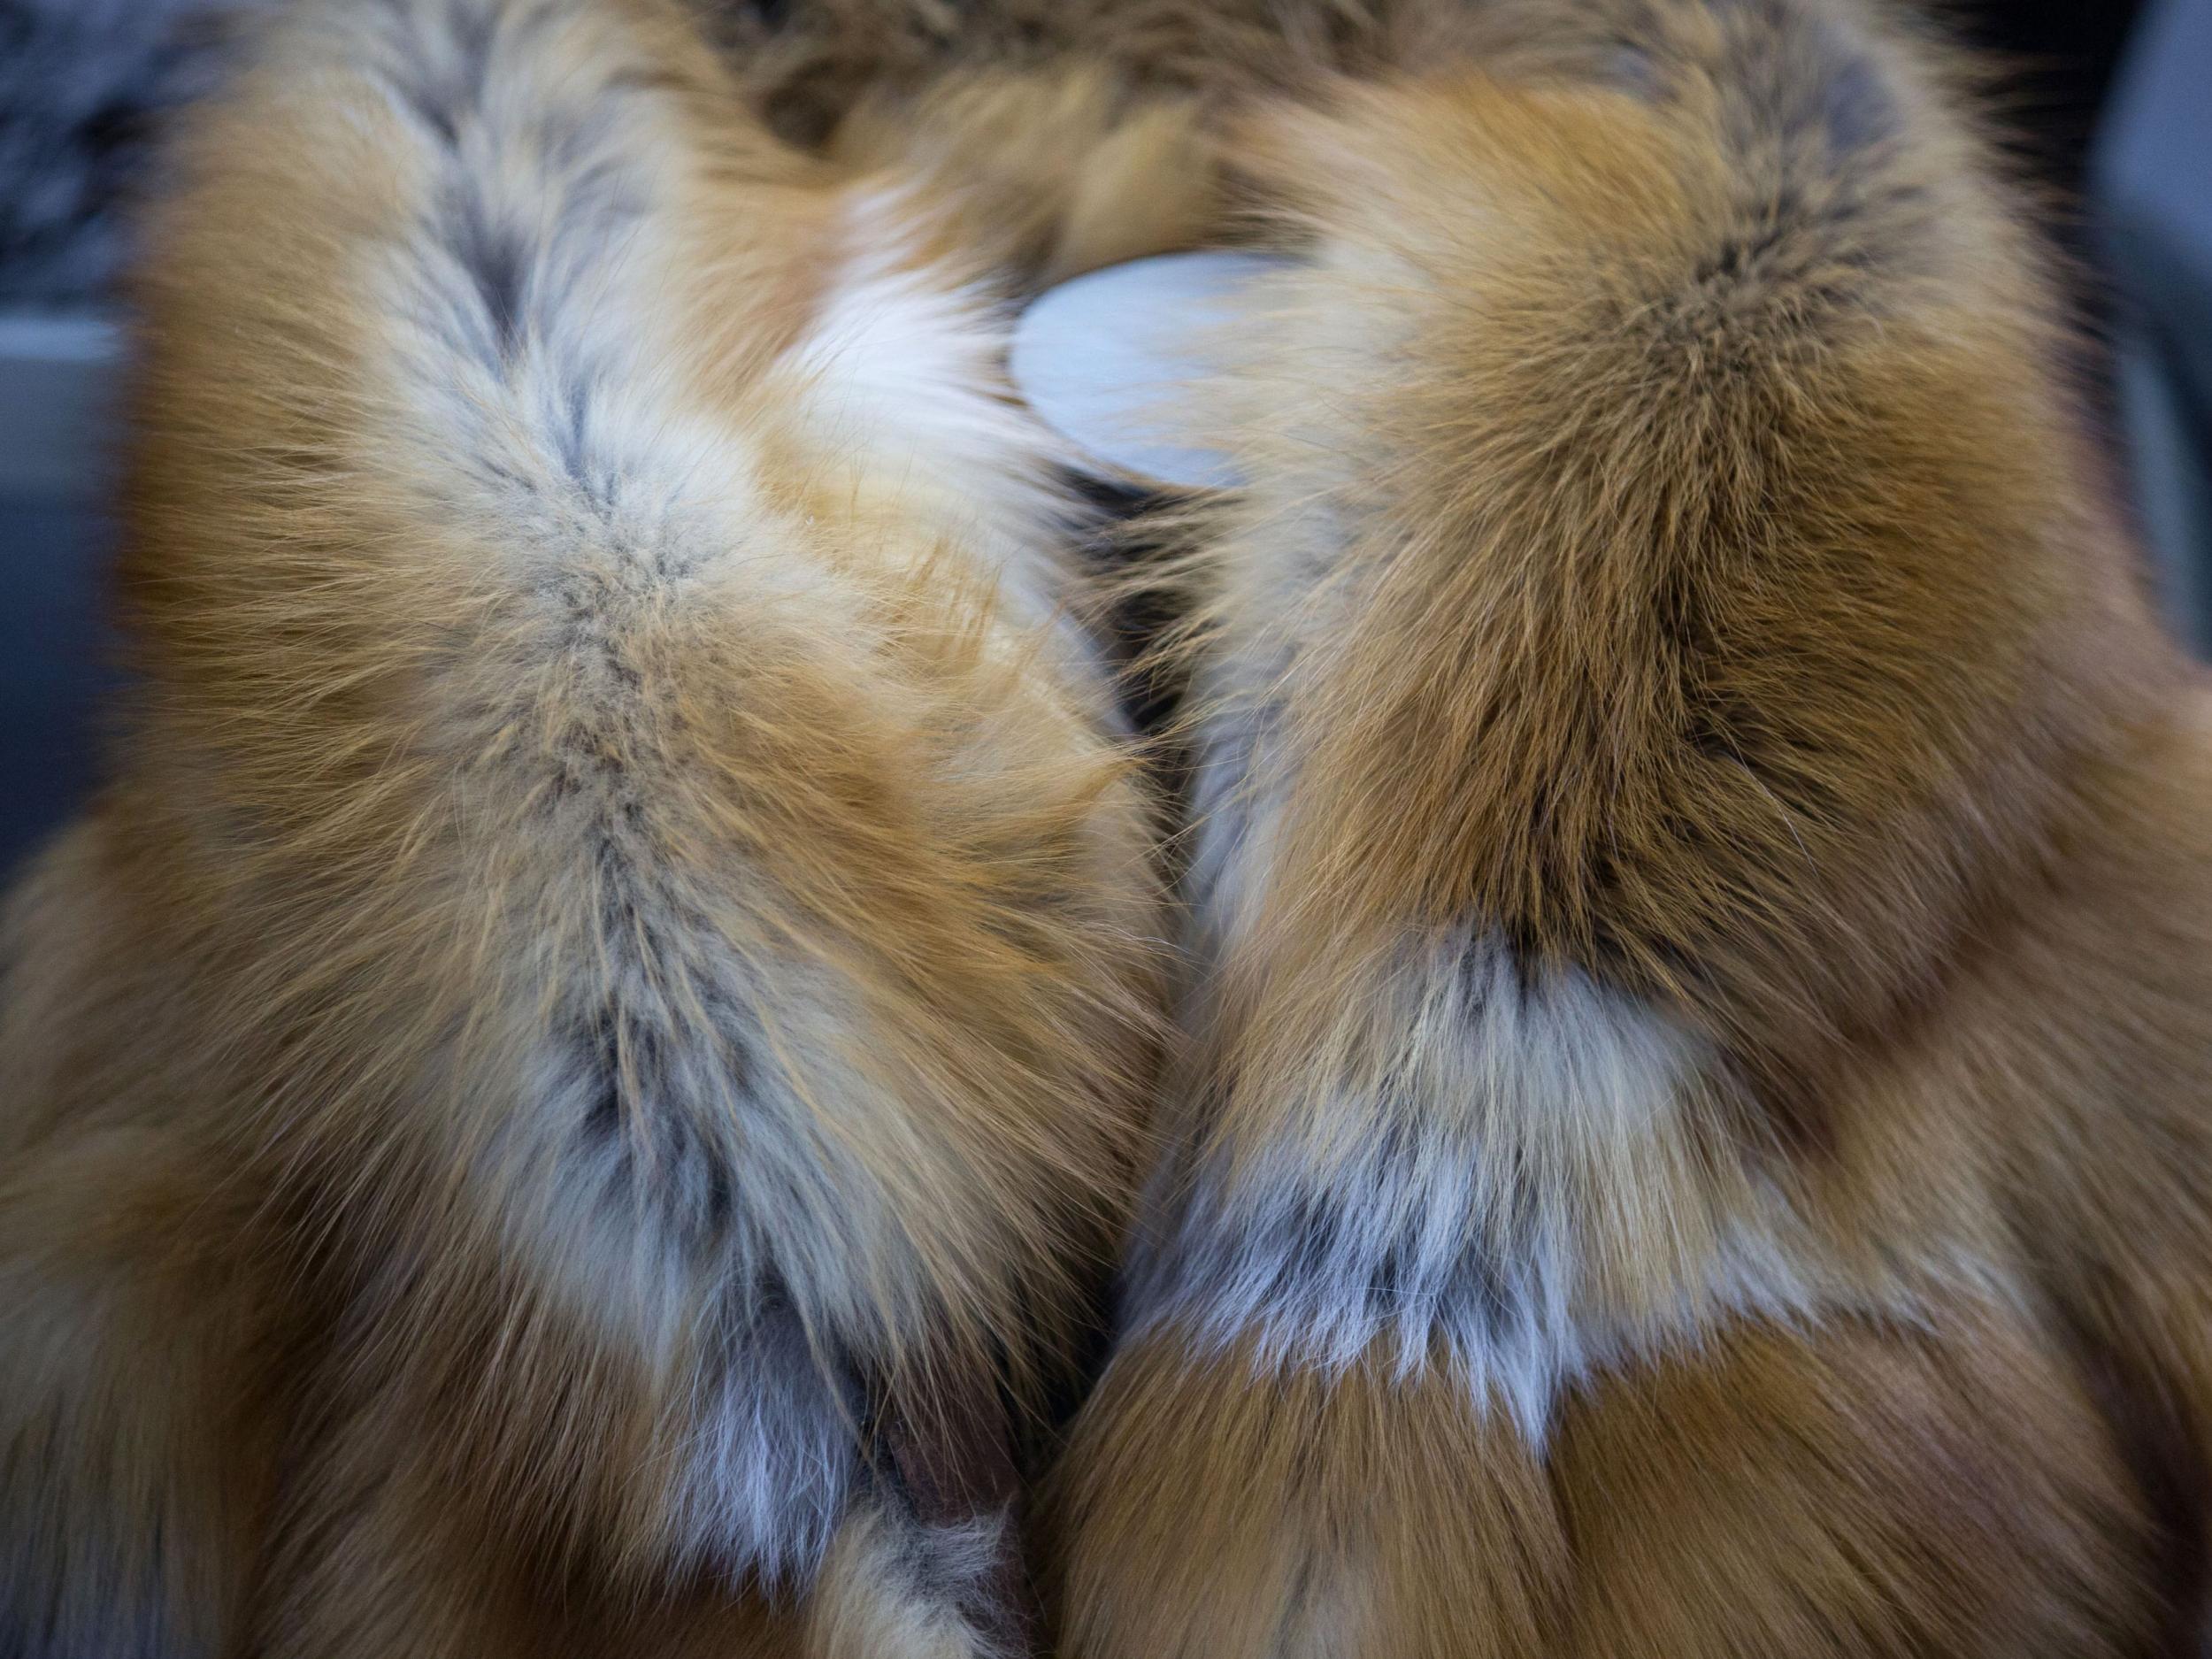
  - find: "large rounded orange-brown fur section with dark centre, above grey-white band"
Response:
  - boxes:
[1202,0,2139,1113]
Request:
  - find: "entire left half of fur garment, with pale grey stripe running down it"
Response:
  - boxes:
[0,0,1162,1659]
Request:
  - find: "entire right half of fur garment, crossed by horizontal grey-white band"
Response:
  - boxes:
[1026,0,2212,1659]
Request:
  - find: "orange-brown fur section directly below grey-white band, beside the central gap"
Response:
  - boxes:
[1051,1340,1569,1659]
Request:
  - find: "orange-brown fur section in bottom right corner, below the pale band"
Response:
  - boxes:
[1551,1310,2157,1659]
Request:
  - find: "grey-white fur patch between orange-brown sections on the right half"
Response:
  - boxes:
[1126,936,1694,1436]
